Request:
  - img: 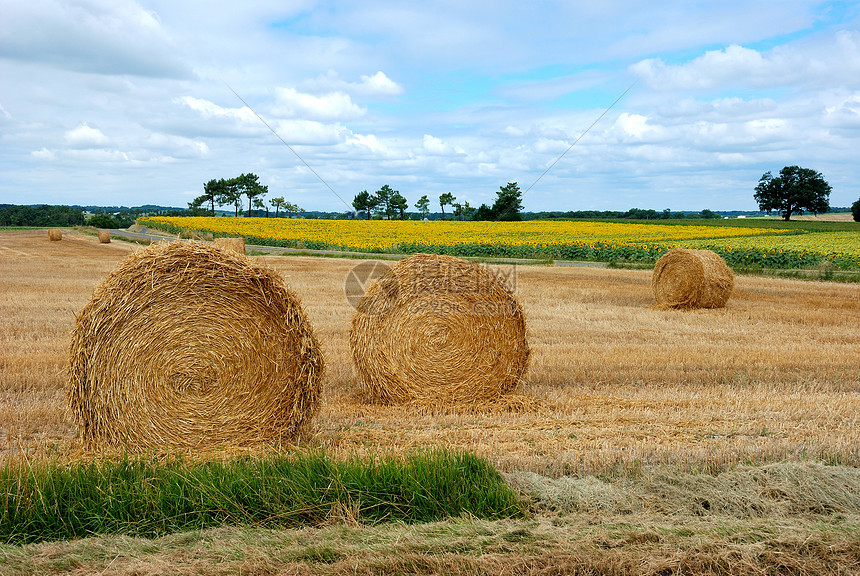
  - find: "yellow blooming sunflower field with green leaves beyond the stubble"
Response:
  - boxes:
[138,216,860,269]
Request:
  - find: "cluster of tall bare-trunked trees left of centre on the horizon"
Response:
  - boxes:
[188,173,304,218]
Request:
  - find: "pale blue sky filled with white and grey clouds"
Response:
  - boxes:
[0,0,860,211]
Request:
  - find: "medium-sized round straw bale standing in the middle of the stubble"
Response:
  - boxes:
[349,254,529,405]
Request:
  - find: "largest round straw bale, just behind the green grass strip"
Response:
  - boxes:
[68,241,324,449]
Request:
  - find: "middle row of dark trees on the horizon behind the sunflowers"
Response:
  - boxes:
[352,182,523,220]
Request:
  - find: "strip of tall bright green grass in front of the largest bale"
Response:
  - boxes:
[0,450,524,544]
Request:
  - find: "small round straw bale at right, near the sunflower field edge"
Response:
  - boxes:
[651,248,735,309]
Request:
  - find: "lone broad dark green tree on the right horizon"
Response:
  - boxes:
[753,166,831,222]
